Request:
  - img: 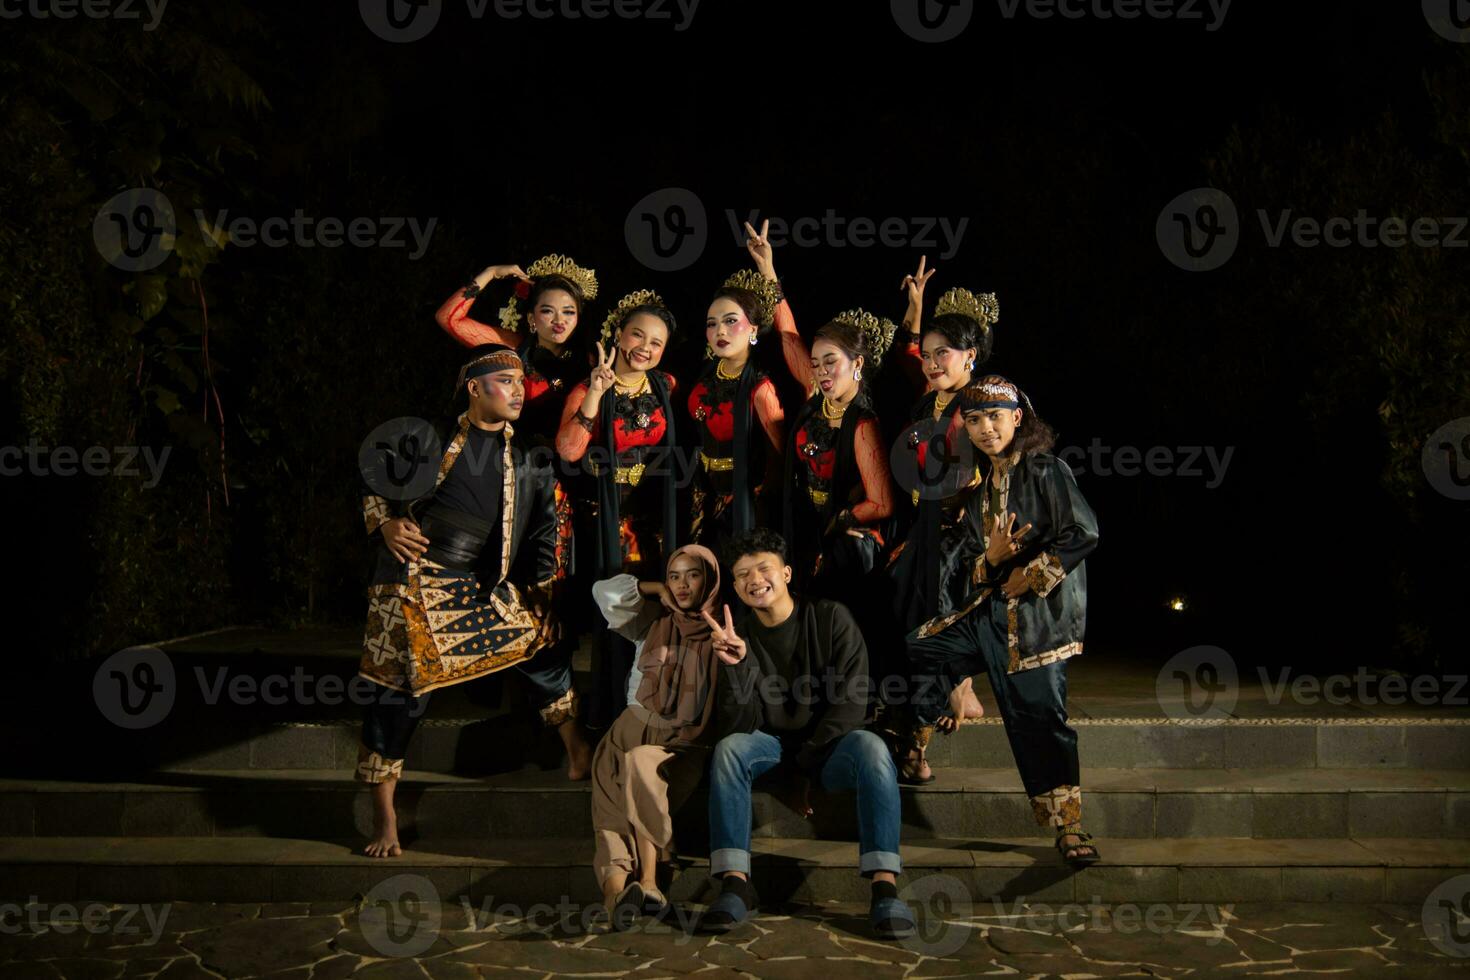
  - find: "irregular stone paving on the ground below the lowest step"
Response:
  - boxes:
[0,892,1470,980]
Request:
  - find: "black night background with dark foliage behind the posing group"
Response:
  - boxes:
[0,0,1470,670]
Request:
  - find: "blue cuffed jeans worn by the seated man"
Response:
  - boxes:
[710,730,903,877]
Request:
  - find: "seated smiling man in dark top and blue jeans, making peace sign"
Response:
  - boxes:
[700,527,914,939]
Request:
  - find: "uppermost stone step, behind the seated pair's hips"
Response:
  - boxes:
[22,710,1470,777]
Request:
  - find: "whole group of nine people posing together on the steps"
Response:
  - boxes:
[356,225,1100,939]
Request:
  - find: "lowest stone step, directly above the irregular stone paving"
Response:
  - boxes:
[0,837,1470,909]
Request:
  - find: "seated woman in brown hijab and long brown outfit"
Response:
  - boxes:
[592,545,735,929]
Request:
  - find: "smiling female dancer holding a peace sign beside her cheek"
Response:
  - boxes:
[556,289,679,727]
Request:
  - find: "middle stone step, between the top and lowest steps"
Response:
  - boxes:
[0,768,1470,846]
